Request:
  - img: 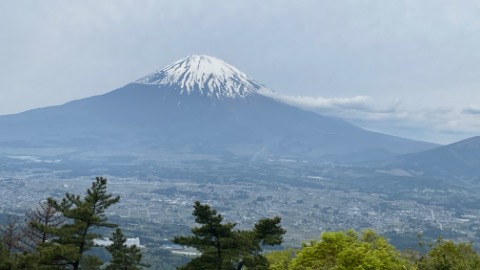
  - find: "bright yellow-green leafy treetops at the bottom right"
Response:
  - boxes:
[266,230,480,270]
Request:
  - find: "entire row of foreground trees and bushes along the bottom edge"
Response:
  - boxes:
[0,177,480,270]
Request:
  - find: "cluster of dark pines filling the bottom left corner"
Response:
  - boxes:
[0,177,143,270]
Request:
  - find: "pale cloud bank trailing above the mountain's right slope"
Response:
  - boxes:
[266,93,480,144]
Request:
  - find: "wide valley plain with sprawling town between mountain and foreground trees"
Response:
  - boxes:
[0,156,480,253]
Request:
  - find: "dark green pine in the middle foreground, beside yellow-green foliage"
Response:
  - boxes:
[173,201,285,270]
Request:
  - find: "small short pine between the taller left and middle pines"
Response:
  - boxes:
[105,228,146,270]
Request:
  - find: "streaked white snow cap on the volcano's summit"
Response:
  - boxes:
[135,55,265,99]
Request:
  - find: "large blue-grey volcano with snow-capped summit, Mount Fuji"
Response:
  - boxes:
[0,55,435,160]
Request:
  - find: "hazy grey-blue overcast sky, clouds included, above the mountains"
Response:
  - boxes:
[0,0,480,143]
